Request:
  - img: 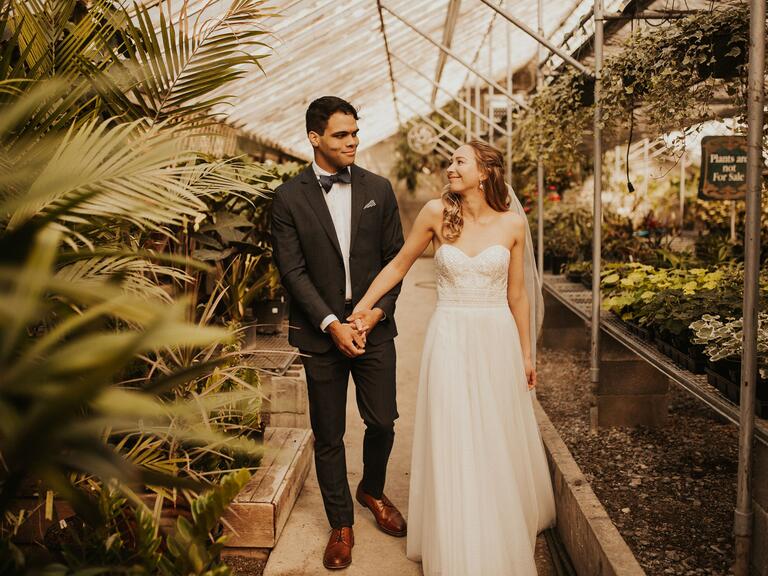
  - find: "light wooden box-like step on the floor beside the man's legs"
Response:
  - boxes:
[220,428,313,548]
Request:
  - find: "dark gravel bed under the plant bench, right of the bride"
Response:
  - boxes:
[537,349,738,576]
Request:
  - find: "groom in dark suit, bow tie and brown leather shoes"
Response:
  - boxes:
[272,96,406,569]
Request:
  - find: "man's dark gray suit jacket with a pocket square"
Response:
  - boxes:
[272,164,403,353]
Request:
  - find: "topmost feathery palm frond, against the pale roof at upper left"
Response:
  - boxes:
[101,0,270,124]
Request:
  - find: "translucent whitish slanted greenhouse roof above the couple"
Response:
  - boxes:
[146,0,584,158]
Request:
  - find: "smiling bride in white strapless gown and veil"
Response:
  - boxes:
[349,141,555,576]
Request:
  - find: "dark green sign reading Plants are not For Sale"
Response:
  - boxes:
[699,136,747,200]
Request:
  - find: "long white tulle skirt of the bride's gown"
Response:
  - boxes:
[407,304,555,576]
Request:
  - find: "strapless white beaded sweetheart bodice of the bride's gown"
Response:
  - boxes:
[435,244,509,308]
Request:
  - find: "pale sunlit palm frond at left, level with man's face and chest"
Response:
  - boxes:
[0,120,205,229]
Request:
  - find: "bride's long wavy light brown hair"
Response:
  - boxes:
[442,140,509,242]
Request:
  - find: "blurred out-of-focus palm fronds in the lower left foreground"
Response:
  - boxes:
[0,228,234,514]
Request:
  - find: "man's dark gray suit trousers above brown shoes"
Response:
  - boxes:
[302,308,398,528]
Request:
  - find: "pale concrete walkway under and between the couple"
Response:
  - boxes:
[264,258,554,576]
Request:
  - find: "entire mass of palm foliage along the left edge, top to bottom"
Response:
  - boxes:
[0,0,278,560]
